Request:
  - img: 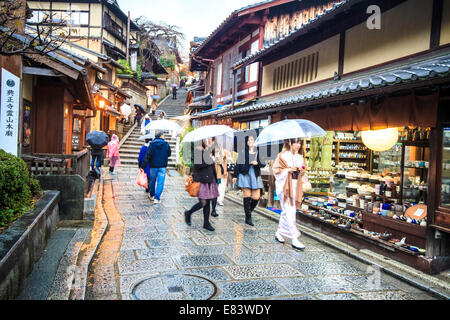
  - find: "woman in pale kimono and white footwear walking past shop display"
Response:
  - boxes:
[273,139,307,250]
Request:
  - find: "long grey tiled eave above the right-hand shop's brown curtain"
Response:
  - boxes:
[219,50,450,117]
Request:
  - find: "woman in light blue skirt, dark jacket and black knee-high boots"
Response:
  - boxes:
[233,134,264,226]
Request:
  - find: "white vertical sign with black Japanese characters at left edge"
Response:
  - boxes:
[0,69,20,156]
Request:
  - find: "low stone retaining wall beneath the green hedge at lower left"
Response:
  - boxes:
[0,191,60,300]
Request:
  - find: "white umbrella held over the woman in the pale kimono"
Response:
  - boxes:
[255,119,327,146]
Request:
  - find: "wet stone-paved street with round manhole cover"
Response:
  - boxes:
[86,167,440,300]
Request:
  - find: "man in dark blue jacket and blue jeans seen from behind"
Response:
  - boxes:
[140,131,172,204]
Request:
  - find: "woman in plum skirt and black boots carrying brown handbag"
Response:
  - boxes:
[184,139,219,231]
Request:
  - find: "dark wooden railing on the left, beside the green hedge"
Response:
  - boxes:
[21,149,91,178]
